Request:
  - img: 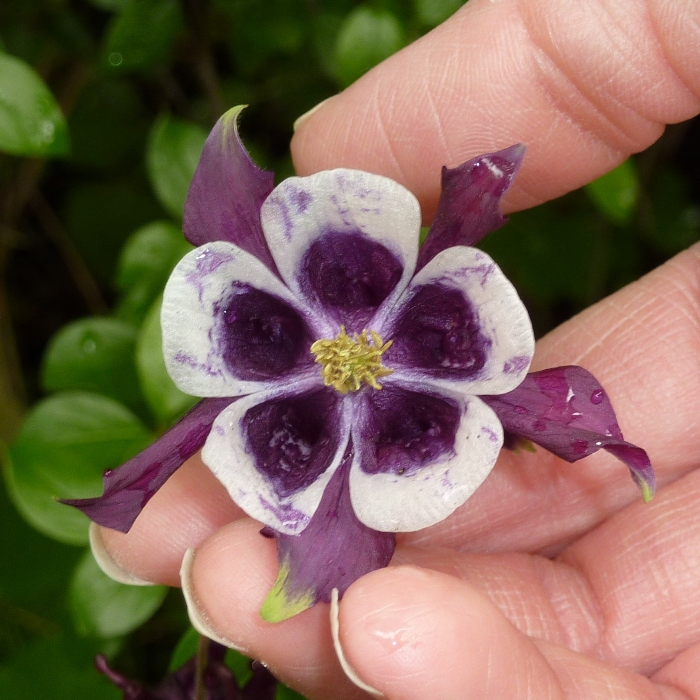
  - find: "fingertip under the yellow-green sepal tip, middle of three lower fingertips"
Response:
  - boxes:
[182,518,366,700]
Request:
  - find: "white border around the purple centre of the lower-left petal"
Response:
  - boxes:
[202,382,350,535]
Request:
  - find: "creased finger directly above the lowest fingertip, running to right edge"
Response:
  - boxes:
[393,471,700,674]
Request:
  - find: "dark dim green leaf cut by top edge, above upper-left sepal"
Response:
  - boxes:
[104,0,183,72]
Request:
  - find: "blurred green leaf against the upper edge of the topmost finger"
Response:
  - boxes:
[335,6,406,87]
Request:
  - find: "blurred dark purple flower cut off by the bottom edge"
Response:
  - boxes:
[95,642,277,700]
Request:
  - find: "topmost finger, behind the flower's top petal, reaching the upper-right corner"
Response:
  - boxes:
[292,0,700,220]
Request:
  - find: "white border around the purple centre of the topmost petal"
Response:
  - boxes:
[261,169,421,332]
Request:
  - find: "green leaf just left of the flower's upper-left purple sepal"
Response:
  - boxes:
[146,114,207,219]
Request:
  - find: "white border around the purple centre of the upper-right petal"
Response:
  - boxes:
[382,246,535,395]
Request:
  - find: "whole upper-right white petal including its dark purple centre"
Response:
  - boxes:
[380,246,535,394]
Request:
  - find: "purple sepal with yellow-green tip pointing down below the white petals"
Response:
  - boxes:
[261,449,394,622]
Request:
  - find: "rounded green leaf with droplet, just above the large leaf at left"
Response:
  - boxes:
[43,318,145,422]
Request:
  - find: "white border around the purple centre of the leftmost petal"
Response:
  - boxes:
[161,241,308,397]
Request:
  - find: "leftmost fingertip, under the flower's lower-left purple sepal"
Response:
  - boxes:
[99,455,243,586]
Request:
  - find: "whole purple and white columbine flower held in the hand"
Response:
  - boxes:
[67,108,654,620]
